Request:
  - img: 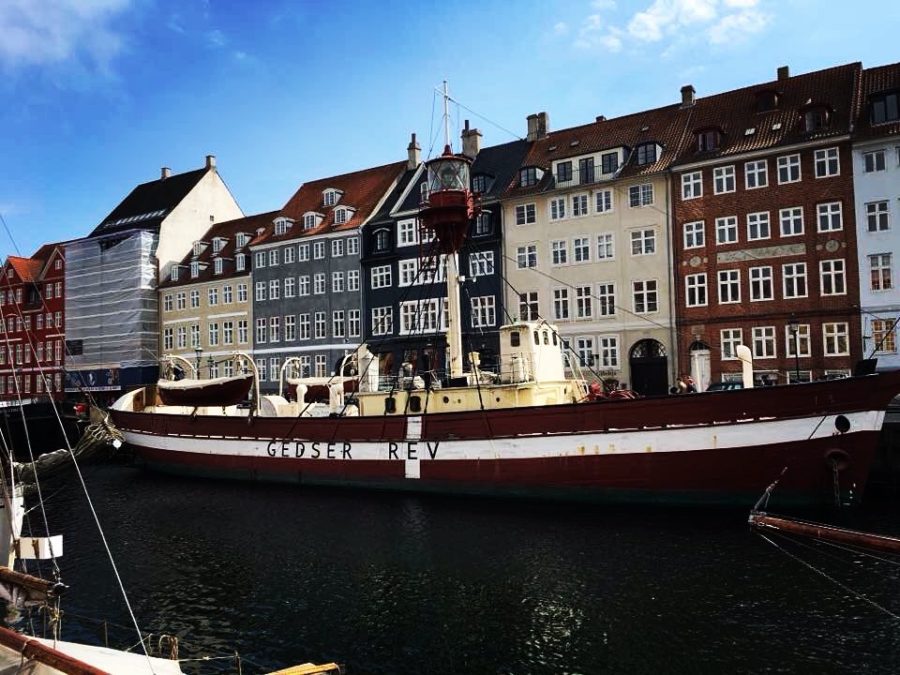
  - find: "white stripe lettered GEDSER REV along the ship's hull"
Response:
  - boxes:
[123,411,884,462]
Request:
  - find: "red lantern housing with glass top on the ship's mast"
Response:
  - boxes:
[419,145,478,253]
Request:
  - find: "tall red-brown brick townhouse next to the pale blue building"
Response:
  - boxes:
[672,63,862,385]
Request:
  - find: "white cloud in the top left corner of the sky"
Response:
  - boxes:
[0,0,131,70]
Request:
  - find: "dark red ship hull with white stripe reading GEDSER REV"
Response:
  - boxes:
[112,373,900,503]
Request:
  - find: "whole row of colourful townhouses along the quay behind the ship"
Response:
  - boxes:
[0,63,900,400]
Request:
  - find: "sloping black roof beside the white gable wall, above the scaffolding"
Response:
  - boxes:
[88,168,211,237]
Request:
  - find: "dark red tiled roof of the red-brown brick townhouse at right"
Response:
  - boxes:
[674,63,861,164]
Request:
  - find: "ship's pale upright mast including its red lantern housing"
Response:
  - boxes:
[419,80,477,378]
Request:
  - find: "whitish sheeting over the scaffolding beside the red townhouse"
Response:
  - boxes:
[66,230,159,370]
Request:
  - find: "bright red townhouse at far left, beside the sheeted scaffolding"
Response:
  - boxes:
[0,244,65,403]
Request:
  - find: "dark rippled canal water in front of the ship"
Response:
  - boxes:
[19,465,900,675]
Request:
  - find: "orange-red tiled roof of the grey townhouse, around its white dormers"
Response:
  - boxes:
[252,161,406,245]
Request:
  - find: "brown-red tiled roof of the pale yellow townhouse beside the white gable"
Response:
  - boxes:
[159,211,278,288]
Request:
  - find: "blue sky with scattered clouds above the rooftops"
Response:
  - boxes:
[0,0,900,259]
